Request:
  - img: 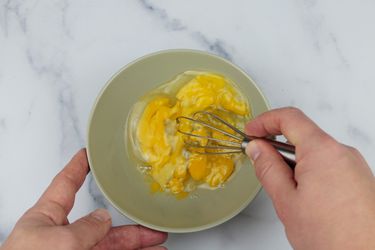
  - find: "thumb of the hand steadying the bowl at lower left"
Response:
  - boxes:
[67,208,112,249]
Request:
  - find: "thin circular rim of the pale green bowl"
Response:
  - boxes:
[86,49,270,233]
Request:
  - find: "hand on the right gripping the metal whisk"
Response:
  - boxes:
[246,108,375,250]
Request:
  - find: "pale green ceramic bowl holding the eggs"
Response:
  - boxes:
[87,50,269,233]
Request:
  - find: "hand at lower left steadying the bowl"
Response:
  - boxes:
[2,149,167,250]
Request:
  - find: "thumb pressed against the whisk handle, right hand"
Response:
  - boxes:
[246,139,296,207]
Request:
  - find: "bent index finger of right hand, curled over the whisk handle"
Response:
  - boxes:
[246,108,329,150]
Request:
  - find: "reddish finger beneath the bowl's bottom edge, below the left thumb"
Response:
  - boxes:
[95,225,168,250]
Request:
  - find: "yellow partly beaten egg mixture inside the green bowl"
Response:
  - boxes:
[131,71,250,197]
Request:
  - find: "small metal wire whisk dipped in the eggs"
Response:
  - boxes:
[176,111,296,169]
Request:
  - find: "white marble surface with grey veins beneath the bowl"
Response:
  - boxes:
[0,0,375,250]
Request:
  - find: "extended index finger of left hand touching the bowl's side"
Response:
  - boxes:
[31,149,89,225]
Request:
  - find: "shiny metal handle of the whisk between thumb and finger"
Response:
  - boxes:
[242,136,296,169]
